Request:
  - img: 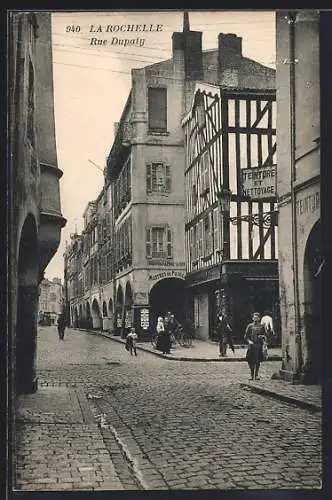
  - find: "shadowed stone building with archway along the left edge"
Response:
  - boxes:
[8,12,66,394]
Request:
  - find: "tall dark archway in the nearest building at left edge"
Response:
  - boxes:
[15,214,39,394]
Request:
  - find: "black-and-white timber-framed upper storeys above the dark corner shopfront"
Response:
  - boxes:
[182,84,277,272]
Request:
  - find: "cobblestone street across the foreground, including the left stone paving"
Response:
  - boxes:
[16,327,321,490]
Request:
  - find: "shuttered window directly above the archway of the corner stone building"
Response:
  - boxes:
[146,226,173,259]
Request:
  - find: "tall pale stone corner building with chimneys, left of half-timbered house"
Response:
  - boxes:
[63,14,275,335]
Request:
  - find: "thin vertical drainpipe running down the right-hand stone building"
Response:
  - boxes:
[288,11,303,374]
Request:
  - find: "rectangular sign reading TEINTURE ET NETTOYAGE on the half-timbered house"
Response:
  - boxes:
[241,165,277,200]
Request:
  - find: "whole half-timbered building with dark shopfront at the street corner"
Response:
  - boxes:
[182,83,279,342]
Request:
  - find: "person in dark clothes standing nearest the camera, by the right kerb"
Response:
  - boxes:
[244,312,265,380]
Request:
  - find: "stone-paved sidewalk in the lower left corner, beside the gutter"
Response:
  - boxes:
[14,386,123,491]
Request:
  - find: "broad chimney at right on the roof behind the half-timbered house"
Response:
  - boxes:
[218,33,242,87]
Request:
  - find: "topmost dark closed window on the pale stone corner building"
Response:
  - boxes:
[148,87,167,133]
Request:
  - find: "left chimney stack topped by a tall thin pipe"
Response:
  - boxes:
[172,12,203,80]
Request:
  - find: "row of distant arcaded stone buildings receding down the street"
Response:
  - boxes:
[64,186,114,330]
